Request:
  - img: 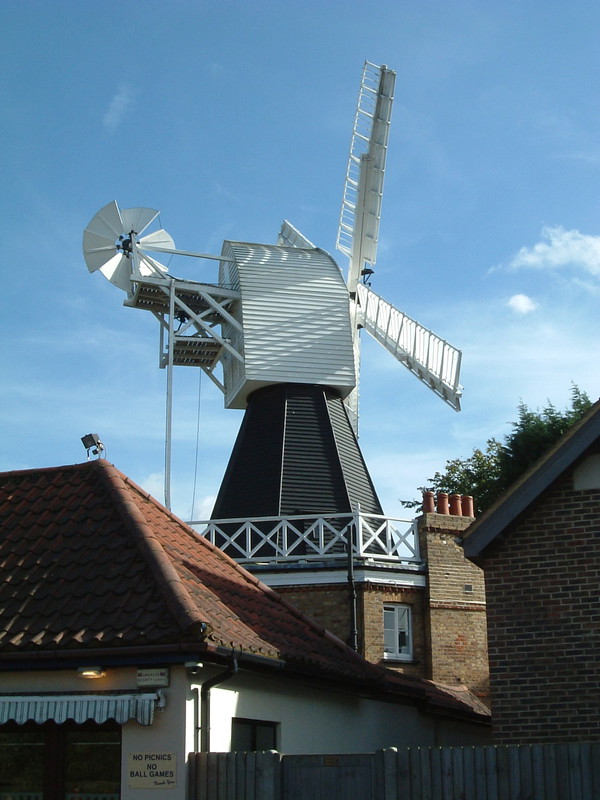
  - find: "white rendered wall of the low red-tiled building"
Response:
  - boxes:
[0,666,489,800]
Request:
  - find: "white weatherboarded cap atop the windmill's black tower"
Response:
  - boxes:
[219,241,356,408]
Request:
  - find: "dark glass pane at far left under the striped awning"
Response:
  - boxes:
[0,731,44,800]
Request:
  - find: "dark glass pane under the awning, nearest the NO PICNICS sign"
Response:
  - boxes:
[65,730,121,800]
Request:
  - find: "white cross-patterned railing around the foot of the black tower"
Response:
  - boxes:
[190,512,420,563]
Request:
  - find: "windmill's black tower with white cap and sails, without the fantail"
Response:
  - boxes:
[206,62,461,519]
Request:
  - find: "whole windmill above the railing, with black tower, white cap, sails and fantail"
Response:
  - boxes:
[83,62,461,519]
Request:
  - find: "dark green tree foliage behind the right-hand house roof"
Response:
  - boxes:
[402,386,592,514]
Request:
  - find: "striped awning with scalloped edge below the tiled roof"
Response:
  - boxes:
[0,692,162,725]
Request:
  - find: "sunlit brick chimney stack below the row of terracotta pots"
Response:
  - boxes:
[419,513,489,700]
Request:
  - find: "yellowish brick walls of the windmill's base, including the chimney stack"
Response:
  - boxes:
[277,513,489,701]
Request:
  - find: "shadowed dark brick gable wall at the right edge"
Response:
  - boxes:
[483,473,600,744]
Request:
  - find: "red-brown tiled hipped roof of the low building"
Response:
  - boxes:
[0,460,488,714]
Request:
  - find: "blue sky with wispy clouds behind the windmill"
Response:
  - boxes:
[0,0,600,518]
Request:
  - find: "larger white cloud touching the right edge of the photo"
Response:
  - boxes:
[510,226,600,275]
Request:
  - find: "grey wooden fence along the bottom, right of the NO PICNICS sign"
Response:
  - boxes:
[190,742,600,800]
